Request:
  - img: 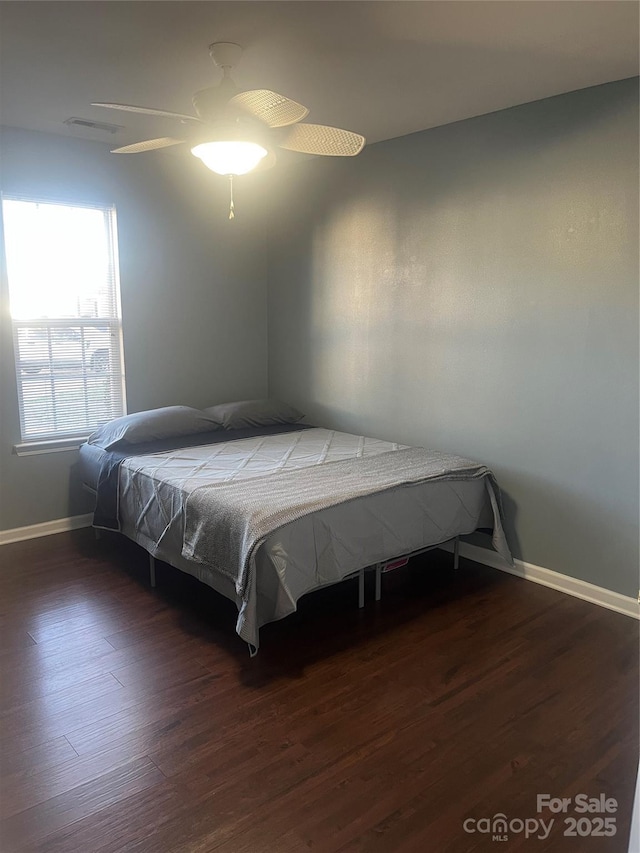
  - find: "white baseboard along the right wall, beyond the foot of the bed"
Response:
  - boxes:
[440,542,640,619]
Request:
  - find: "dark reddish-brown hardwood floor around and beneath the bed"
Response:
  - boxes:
[0,530,638,853]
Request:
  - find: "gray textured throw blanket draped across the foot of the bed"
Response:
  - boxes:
[182,448,512,601]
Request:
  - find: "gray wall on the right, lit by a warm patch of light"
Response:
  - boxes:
[269,80,638,596]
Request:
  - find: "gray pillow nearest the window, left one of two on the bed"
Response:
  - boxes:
[88,406,222,450]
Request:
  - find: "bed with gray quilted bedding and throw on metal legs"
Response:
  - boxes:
[80,401,511,654]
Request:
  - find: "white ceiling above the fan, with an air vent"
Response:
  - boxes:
[0,0,639,152]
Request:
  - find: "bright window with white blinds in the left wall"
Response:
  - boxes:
[2,196,125,442]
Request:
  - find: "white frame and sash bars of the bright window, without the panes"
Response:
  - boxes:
[0,192,127,446]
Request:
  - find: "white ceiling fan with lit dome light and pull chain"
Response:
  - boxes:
[92,42,366,219]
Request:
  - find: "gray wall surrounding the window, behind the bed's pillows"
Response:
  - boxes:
[0,130,267,530]
